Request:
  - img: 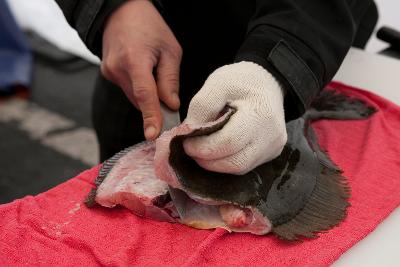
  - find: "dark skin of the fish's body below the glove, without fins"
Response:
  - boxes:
[169,118,321,225]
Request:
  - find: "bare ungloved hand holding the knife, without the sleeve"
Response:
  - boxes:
[101,0,182,140]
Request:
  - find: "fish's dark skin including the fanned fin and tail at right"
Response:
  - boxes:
[169,90,375,240]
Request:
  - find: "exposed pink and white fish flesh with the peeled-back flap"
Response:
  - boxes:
[90,113,271,235]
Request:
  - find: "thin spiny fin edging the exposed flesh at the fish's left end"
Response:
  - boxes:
[84,145,137,208]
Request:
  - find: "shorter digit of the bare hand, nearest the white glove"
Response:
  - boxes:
[157,52,181,110]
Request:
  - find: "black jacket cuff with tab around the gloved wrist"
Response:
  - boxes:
[235,25,324,120]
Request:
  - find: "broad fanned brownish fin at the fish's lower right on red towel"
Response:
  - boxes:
[272,167,350,241]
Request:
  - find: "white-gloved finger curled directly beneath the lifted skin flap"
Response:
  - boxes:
[183,111,253,160]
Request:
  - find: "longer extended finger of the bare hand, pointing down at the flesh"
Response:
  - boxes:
[130,62,162,140]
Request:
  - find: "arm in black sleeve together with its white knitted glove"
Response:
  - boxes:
[184,0,376,174]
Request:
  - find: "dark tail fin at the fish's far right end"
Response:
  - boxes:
[305,89,376,120]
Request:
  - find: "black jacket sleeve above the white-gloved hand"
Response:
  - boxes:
[236,0,372,119]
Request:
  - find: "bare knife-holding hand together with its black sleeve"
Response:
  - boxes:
[57,0,182,142]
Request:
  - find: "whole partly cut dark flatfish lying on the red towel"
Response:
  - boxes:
[88,90,374,240]
